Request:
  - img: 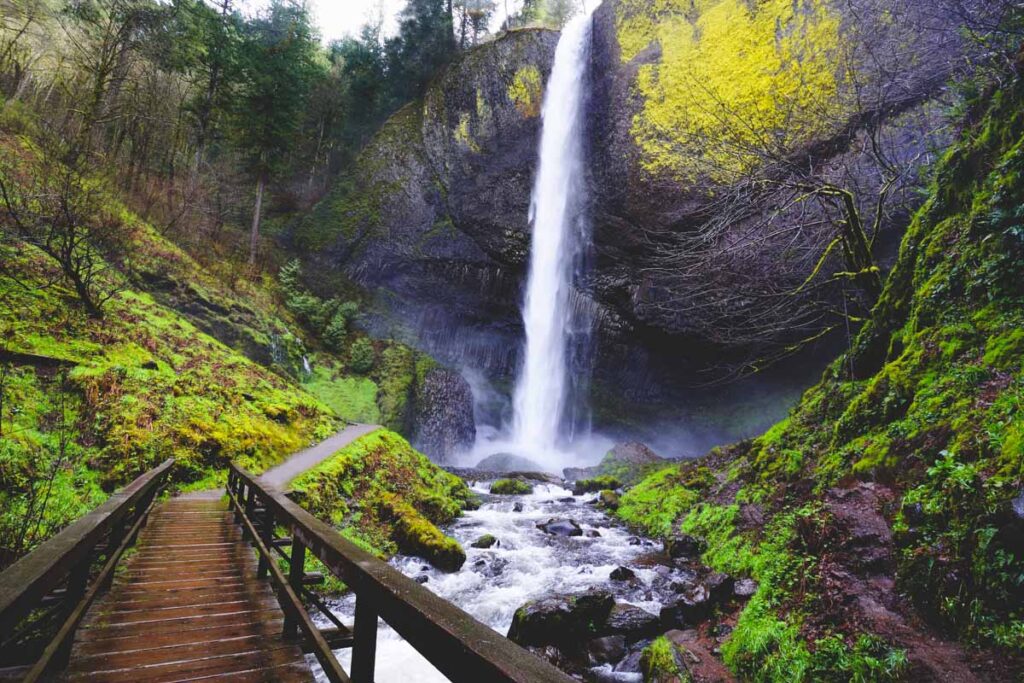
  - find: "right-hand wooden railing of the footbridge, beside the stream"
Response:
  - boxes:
[227,464,572,683]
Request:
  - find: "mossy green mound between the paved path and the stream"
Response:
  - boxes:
[292,429,476,570]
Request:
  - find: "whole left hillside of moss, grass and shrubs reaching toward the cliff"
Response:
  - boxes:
[0,113,462,564]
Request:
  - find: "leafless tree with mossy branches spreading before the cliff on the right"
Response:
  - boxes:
[640,0,995,381]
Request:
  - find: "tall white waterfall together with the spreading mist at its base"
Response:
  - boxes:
[466,6,610,471]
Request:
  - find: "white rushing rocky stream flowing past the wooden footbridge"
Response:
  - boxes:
[307,479,755,683]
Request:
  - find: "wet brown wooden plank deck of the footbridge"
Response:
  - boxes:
[67,497,312,683]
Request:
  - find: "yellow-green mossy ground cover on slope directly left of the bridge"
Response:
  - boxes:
[0,125,346,564]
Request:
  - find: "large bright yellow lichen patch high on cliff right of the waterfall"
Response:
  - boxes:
[618,0,843,181]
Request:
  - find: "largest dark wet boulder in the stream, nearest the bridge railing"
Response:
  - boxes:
[508,589,615,646]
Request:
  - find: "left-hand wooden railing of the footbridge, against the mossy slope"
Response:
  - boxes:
[0,459,174,681]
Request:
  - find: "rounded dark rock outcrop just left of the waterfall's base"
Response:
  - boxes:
[412,368,476,463]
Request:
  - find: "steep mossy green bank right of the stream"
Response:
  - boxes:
[617,69,1024,681]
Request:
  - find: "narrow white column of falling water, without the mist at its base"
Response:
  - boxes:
[512,7,591,455]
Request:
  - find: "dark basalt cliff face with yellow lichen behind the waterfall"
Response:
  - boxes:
[292,0,964,432]
